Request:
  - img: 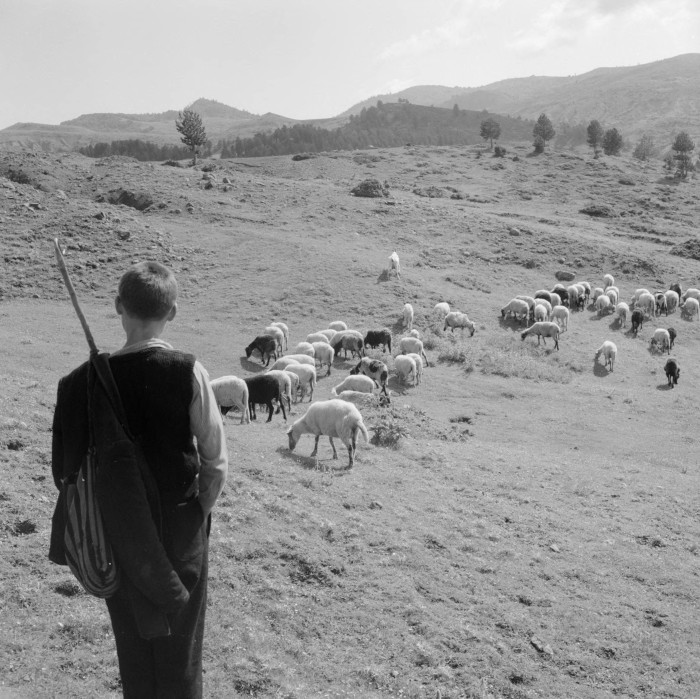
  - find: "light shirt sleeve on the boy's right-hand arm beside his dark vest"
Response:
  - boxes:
[190,361,228,517]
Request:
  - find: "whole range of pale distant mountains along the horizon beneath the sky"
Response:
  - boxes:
[0,53,700,150]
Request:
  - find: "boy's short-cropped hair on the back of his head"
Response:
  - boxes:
[119,262,177,320]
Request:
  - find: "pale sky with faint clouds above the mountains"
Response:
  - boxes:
[0,0,700,129]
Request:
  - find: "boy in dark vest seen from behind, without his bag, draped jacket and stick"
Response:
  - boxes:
[49,262,228,699]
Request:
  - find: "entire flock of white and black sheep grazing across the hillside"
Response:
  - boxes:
[211,252,700,468]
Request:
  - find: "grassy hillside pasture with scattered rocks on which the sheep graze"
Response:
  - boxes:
[0,143,700,699]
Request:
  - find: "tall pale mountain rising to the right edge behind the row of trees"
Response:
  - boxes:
[343,53,700,143]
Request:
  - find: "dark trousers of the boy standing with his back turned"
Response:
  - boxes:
[107,504,208,699]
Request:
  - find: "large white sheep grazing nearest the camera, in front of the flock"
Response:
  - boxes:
[287,399,369,468]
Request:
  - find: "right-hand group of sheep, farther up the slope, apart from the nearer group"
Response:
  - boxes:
[501,274,700,388]
